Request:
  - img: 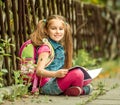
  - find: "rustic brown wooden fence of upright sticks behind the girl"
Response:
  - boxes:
[0,0,120,85]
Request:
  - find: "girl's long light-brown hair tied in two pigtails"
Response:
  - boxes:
[30,15,73,68]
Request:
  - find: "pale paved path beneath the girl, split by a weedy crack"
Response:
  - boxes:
[3,76,120,105]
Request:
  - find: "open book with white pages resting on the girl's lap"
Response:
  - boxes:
[69,66,102,79]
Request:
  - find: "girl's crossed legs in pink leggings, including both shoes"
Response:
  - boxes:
[57,69,92,96]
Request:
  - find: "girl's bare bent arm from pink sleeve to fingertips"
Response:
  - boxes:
[36,52,68,78]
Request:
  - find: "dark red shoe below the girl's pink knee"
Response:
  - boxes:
[64,86,82,96]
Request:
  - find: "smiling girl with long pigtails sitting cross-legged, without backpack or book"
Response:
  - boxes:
[26,15,92,96]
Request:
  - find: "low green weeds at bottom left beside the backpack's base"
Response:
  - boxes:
[0,71,31,103]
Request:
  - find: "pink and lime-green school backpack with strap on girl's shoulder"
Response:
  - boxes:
[19,39,54,93]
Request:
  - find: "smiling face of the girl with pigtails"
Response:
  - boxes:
[47,19,65,42]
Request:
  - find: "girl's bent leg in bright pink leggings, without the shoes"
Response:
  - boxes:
[57,69,84,91]
